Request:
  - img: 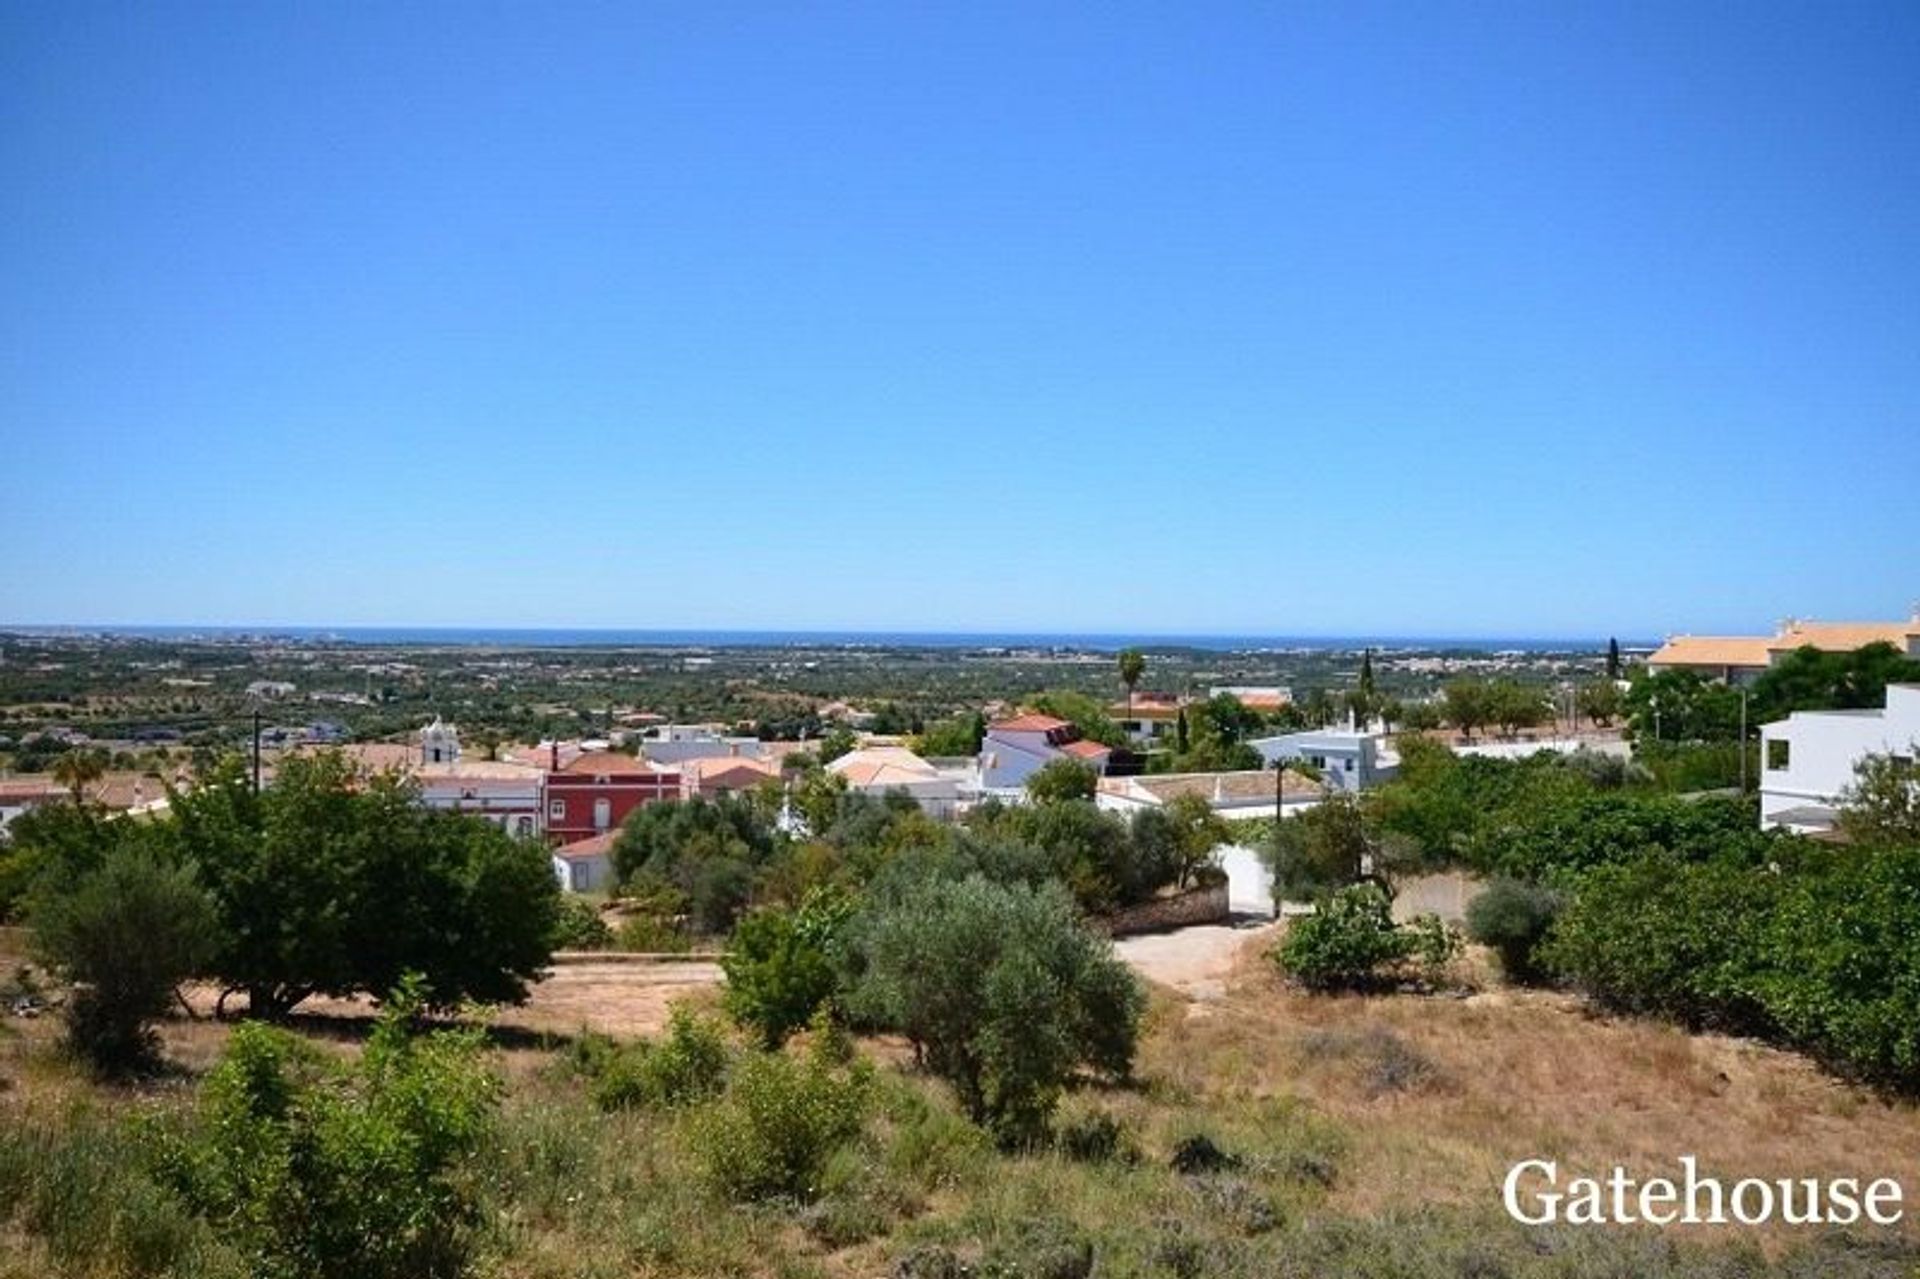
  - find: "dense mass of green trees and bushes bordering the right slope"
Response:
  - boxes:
[1269,745,1920,1091]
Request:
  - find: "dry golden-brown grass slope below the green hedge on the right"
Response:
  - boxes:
[1144,921,1920,1236]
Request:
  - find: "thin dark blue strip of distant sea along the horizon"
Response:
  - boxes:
[0,626,1651,653]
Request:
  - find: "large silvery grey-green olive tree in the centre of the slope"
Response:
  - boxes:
[852,876,1146,1145]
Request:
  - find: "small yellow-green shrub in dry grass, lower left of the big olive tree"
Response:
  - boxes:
[689,1029,874,1202]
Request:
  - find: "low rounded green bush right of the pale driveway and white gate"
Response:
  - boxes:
[1273,883,1459,991]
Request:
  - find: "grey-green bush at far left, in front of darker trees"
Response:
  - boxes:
[29,837,213,1072]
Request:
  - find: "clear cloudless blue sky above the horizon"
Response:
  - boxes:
[0,2,1920,636]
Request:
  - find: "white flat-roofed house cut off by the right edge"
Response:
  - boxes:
[1761,684,1920,833]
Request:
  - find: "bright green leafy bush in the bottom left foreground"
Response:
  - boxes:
[154,981,499,1279]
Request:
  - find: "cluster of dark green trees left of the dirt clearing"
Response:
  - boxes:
[0,755,563,1068]
